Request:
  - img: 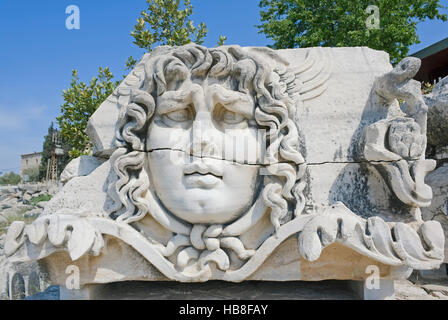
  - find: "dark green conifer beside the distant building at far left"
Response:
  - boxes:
[39,122,72,180]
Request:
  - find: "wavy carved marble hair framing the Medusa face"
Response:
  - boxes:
[109,44,306,230]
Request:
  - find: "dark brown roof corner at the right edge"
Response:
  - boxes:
[412,38,448,84]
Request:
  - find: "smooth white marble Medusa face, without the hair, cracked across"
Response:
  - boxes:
[147,79,262,223]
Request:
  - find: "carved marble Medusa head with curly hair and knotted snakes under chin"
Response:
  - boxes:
[110,46,316,278]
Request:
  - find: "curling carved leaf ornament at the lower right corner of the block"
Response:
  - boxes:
[298,203,445,269]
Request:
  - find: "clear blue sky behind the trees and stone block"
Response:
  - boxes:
[0,0,448,172]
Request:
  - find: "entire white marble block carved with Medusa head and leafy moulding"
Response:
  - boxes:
[5,44,445,298]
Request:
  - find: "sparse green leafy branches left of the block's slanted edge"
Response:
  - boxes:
[57,67,119,158]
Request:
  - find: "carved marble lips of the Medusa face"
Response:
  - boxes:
[184,161,223,189]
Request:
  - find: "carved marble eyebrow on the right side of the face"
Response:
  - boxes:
[213,86,255,119]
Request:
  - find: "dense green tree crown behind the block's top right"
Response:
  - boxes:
[257,0,447,63]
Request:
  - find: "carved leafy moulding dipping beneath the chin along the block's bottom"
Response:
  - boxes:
[5,203,445,282]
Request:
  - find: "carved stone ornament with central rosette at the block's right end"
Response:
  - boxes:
[361,58,436,221]
